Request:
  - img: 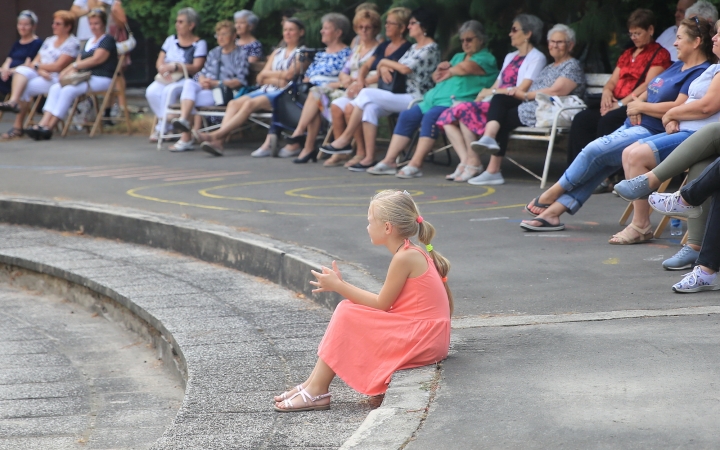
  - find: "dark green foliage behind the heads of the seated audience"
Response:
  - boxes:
[124,0,720,72]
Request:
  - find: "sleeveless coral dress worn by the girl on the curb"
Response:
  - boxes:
[318,240,450,395]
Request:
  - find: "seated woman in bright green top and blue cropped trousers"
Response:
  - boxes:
[368,20,498,178]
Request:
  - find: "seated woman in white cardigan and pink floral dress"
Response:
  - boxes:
[436,14,547,181]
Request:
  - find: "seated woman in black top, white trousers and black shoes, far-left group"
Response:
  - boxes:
[25,9,118,141]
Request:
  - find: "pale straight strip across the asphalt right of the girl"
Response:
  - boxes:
[452,306,720,330]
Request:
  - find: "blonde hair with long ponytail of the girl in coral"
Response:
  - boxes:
[370,190,455,315]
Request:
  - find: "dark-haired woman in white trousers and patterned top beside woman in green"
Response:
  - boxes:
[320,8,440,166]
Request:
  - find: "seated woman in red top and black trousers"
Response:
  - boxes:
[567,9,672,172]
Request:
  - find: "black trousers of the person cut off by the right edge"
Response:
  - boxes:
[680,158,720,272]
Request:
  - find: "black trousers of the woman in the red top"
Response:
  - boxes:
[567,106,627,166]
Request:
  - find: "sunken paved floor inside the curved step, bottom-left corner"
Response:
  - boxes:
[0,284,183,450]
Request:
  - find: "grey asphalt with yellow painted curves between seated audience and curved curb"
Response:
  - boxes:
[0,118,720,448]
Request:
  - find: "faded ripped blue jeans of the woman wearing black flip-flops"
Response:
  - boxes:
[557,125,652,214]
